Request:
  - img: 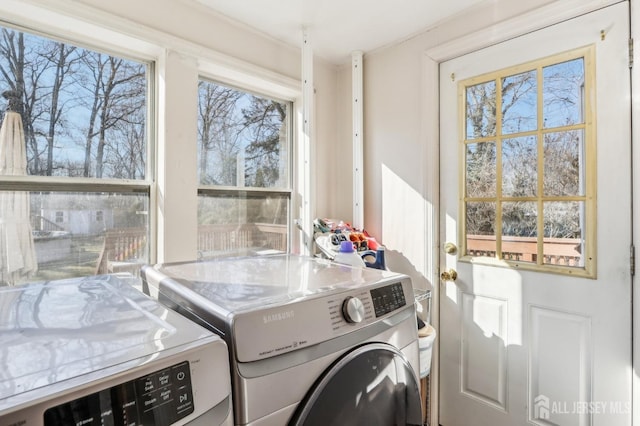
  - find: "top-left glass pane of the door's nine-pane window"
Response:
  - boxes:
[466,81,496,139]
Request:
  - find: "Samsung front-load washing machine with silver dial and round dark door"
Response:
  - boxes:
[141,254,422,426]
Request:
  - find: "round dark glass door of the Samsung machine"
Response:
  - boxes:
[289,343,422,426]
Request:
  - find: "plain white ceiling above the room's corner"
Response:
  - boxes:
[196,0,482,63]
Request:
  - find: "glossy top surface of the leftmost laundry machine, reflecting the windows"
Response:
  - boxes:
[0,275,212,406]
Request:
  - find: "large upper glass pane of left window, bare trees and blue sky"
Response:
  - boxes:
[0,27,149,179]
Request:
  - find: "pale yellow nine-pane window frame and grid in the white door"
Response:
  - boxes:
[458,45,597,278]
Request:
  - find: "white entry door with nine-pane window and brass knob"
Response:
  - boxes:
[439,2,632,426]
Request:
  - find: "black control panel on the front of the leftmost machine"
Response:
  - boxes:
[44,361,194,426]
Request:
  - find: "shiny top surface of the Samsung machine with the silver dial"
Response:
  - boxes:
[142,254,406,316]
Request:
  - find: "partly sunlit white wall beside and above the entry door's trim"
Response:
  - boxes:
[350,0,567,289]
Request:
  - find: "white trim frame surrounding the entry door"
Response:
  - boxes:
[421,0,640,426]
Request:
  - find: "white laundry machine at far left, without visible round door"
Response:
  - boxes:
[0,275,233,426]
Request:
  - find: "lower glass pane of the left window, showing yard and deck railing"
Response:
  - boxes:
[0,191,149,285]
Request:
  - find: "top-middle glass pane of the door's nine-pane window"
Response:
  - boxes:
[502,71,538,135]
